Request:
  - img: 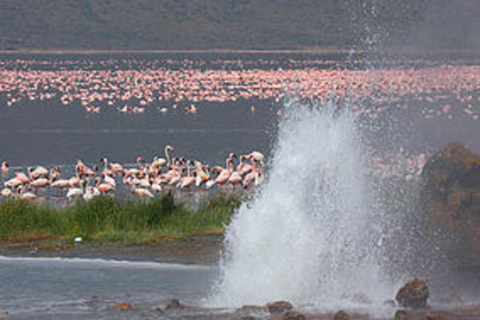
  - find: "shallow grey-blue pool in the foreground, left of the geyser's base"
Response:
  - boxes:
[0,256,216,319]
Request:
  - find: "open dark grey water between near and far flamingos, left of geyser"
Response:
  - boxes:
[0,102,275,166]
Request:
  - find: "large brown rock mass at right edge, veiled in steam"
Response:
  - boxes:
[420,143,480,265]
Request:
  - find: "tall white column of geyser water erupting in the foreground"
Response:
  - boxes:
[209,102,394,309]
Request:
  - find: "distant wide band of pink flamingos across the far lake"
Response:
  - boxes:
[0,59,480,120]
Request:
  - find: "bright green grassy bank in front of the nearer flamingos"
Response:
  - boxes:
[0,194,240,244]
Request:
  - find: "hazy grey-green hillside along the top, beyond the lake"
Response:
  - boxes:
[0,0,480,50]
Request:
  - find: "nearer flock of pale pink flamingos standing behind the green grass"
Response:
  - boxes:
[0,145,265,201]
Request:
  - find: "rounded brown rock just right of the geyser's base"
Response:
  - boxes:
[395,278,430,309]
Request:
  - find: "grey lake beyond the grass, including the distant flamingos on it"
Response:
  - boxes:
[0,54,480,167]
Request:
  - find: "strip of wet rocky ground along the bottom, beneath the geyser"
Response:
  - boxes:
[99,279,480,320]
